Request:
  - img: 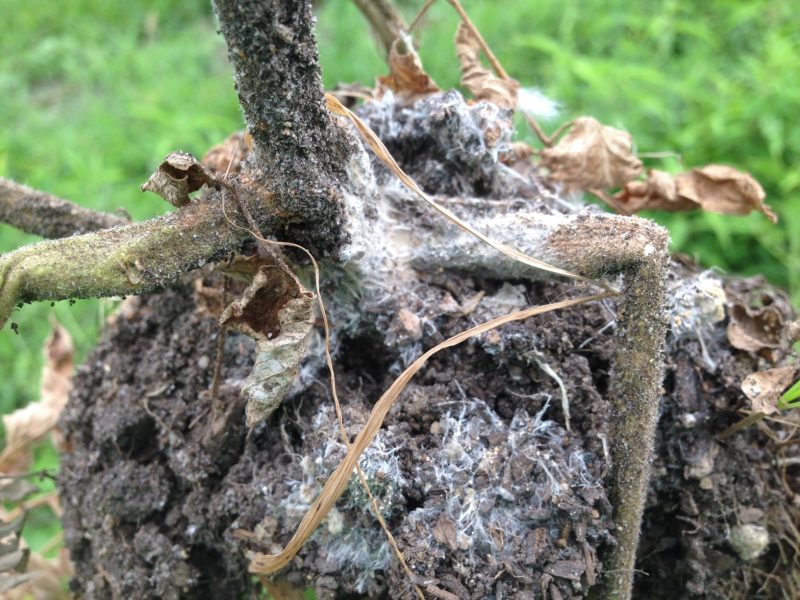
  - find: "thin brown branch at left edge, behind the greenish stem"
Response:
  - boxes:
[0,177,129,238]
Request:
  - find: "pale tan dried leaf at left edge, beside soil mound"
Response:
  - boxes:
[0,323,73,473]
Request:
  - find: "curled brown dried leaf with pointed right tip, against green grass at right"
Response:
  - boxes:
[675,165,778,223]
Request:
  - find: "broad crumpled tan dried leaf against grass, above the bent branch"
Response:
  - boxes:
[539,117,642,190]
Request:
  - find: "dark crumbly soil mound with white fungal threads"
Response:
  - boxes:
[60,95,800,600]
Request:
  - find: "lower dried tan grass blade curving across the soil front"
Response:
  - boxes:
[250,292,615,574]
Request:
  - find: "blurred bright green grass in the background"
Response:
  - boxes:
[0,0,800,546]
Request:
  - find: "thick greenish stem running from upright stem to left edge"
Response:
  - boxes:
[0,188,260,327]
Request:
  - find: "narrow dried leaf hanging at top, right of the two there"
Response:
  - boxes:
[455,21,519,110]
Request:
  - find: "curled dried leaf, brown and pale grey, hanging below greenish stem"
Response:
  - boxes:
[220,266,314,428]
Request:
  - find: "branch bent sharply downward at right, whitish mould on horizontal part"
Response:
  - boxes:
[387,204,669,599]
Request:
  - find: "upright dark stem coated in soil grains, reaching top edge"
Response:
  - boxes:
[213,0,354,255]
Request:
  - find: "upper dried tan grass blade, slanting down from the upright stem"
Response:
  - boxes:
[325,94,609,289]
